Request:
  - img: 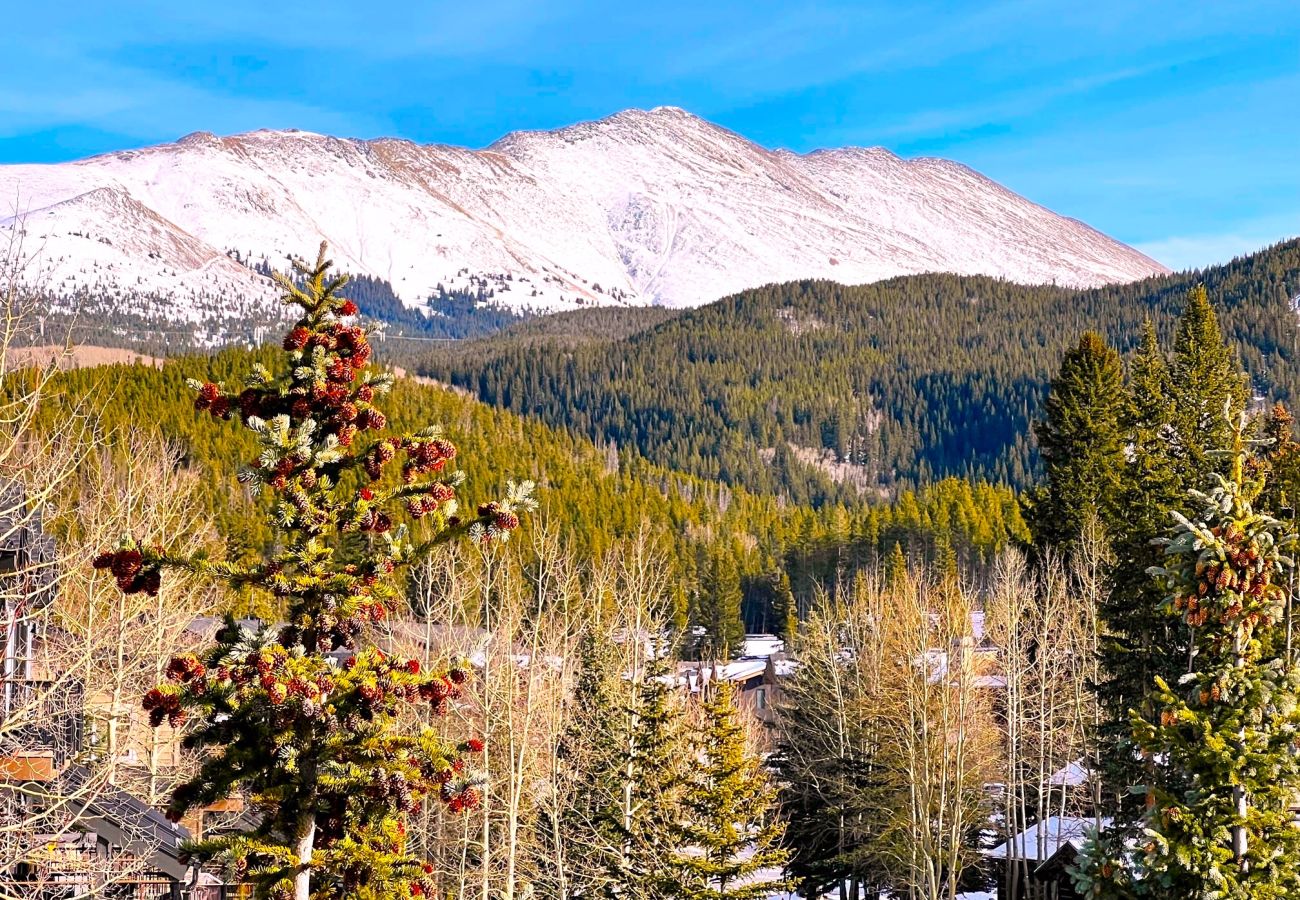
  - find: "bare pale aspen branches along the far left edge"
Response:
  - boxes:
[0,225,188,900]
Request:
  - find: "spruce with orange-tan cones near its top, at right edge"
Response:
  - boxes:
[1082,426,1300,900]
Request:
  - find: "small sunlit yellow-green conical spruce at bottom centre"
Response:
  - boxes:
[667,682,789,900]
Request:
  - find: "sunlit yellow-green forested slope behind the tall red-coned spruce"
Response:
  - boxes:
[20,350,1027,624]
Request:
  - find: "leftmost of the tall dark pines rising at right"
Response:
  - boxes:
[1028,332,1125,549]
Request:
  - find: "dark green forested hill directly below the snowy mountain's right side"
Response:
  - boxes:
[420,241,1300,505]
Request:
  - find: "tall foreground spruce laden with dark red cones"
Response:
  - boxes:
[95,245,533,900]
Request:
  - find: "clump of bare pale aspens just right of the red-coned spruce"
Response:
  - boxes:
[390,528,685,900]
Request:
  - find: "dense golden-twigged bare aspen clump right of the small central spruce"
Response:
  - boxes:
[777,568,998,900]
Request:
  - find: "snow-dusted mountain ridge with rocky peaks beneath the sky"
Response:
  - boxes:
[0,107,1166,320]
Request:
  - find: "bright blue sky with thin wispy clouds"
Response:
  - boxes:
[0,0,1300,268]
